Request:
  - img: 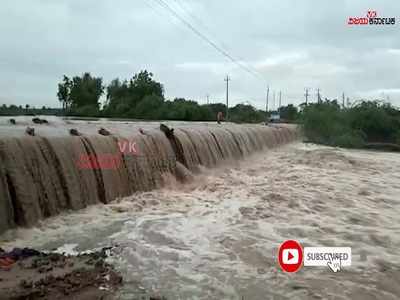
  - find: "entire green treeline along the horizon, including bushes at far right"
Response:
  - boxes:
[0,70,400,149]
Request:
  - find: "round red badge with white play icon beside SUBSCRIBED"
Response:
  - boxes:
[278,240,303,273]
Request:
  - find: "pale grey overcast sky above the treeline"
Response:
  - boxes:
[0,0,400,108]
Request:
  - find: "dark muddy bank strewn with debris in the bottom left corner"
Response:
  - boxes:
[0,248,122,300]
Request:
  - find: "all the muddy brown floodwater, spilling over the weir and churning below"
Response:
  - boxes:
[0,117,400,300]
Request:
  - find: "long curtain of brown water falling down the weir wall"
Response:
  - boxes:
[0,125,299,233]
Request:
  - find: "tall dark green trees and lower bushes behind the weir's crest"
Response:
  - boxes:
[57,70,272,123]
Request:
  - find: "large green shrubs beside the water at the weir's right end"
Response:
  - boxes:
[301,101,400,148]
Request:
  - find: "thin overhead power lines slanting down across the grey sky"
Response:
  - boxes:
[148,0,265,81]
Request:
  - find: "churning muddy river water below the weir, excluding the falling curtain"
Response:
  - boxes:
[1,143,400,299]
